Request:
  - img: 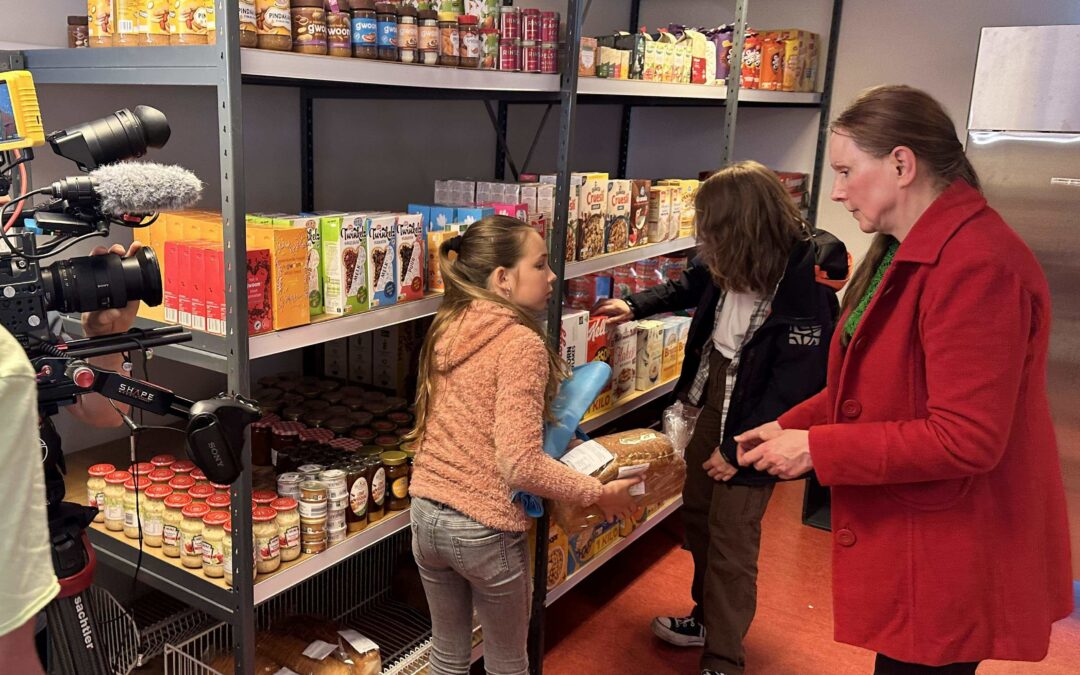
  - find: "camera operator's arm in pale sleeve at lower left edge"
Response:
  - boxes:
[0,328,59,673]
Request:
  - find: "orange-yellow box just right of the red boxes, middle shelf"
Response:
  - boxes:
[247,226,311,330]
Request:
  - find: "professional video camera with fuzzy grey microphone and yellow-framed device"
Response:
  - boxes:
[0,71,259,486]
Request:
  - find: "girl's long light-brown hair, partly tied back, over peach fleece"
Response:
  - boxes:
[405,216,568,442]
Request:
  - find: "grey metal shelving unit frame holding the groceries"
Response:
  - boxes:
[16,0,842,673]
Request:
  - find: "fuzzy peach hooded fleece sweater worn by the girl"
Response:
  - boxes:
[409,301,600,531]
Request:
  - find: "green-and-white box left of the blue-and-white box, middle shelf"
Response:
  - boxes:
[320,214,368,316]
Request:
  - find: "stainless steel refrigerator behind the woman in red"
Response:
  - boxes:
[967,26,1080,579]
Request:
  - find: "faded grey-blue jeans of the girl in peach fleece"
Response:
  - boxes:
[410,498,532,675]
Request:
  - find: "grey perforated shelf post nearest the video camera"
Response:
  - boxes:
[215,0,255,675]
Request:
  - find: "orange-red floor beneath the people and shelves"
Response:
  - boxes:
[544,483,1080,675]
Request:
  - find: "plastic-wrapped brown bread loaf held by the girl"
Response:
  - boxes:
[553,429,686,537]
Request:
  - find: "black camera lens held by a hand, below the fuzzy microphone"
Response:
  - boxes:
[41,247,161,312]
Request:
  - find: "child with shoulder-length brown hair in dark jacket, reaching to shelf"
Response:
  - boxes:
[594,162,849,675]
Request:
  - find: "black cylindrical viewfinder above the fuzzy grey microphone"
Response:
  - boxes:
[49,106,171,171]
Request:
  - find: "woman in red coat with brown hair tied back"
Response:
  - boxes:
[737,86,1072,674]
